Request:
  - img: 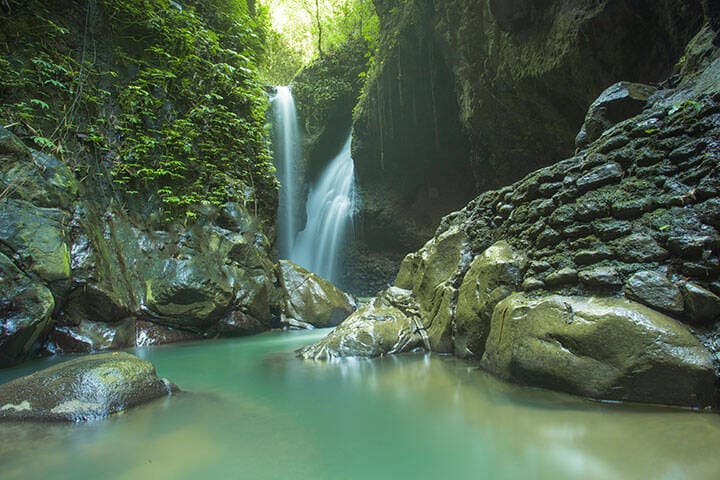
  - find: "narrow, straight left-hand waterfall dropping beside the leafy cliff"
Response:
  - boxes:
[271,87,301,258]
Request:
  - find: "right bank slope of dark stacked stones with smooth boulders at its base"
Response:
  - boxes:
[303,29,720,407]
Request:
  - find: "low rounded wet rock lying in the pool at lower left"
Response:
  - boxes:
[0,352,177,422]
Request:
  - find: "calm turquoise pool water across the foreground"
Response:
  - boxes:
[0,331,720,480]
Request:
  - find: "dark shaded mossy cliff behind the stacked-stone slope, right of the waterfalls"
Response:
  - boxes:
[350,0,703,292]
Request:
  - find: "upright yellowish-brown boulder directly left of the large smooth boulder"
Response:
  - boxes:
[454,241,525,358]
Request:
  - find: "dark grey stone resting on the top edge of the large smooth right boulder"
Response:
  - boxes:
[625,271,685,315]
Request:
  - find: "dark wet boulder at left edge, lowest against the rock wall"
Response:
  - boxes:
[0,253,55,368]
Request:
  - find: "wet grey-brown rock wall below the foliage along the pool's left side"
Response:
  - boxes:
[0,128,290,367]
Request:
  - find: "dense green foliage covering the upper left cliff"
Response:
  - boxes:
[0,0,277,218]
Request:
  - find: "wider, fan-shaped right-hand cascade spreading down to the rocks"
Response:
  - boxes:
[290,135,356,281]
